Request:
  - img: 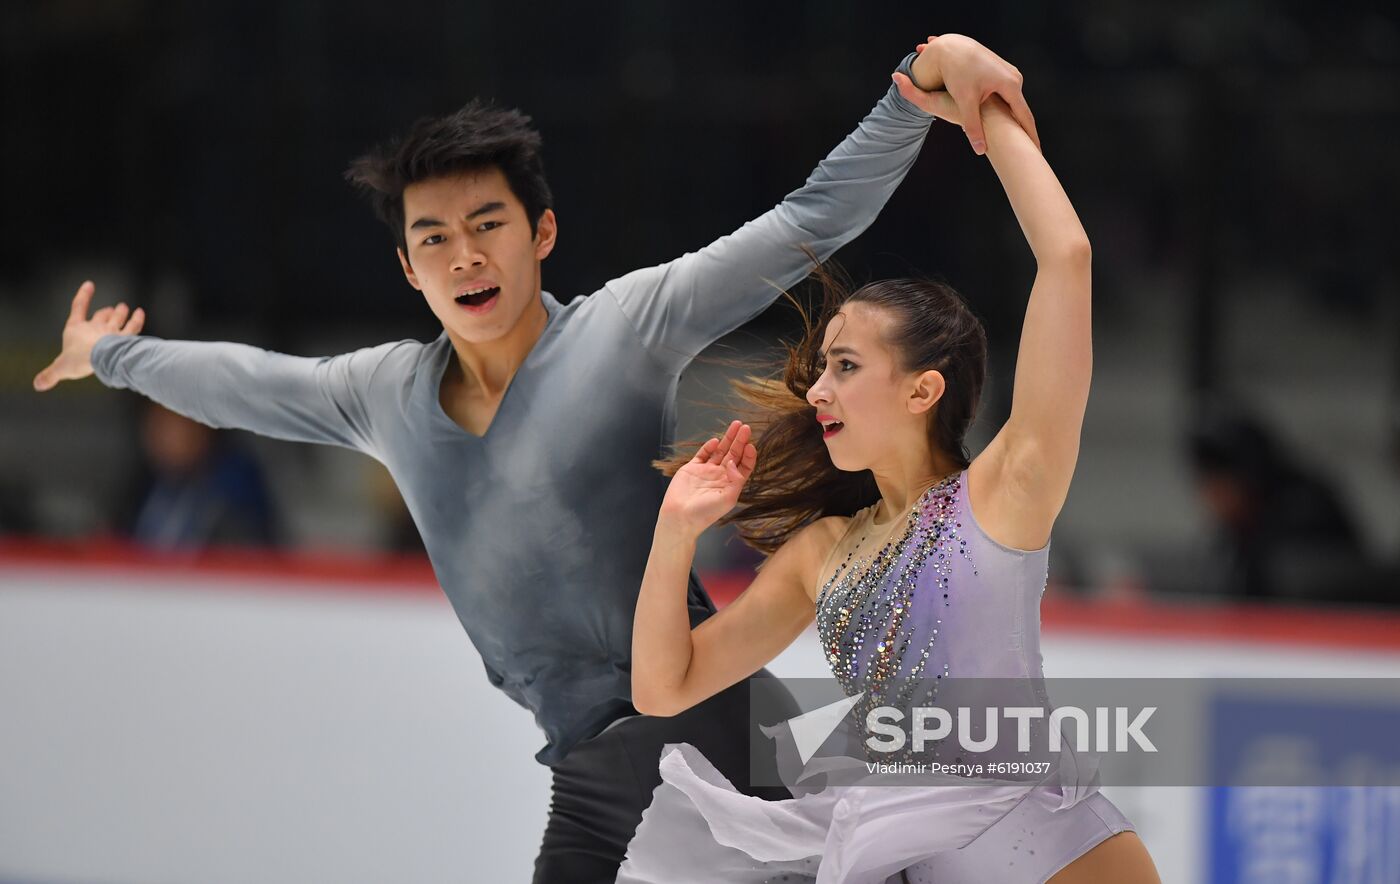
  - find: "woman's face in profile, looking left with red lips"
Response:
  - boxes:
[806,303,942,472]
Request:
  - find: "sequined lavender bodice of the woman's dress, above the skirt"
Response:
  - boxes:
[816,471,1049,711]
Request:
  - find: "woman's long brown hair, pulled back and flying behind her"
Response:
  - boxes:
[655,256,987,555]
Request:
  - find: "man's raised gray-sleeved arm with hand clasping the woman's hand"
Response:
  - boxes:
[605,35,1033,370]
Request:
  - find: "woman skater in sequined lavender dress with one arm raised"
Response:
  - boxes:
[617,78,1158,884]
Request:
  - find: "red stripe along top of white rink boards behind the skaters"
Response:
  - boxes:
[0,539,1400,650]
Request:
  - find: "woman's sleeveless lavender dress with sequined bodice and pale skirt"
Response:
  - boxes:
[617,471,1133,884]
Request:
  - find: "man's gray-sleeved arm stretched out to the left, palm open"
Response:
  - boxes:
[34,282,395,455]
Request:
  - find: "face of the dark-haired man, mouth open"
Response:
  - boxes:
[399,167,556,343]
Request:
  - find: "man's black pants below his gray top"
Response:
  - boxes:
[533,670,798,884]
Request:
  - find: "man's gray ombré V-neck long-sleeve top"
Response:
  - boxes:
[92,64,932,764]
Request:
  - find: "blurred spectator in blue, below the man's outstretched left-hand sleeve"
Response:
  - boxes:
[123,402,277,551]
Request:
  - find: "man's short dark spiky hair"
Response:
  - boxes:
[346,98,553,255]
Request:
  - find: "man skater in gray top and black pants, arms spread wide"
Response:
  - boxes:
[35,35,1035,884]
